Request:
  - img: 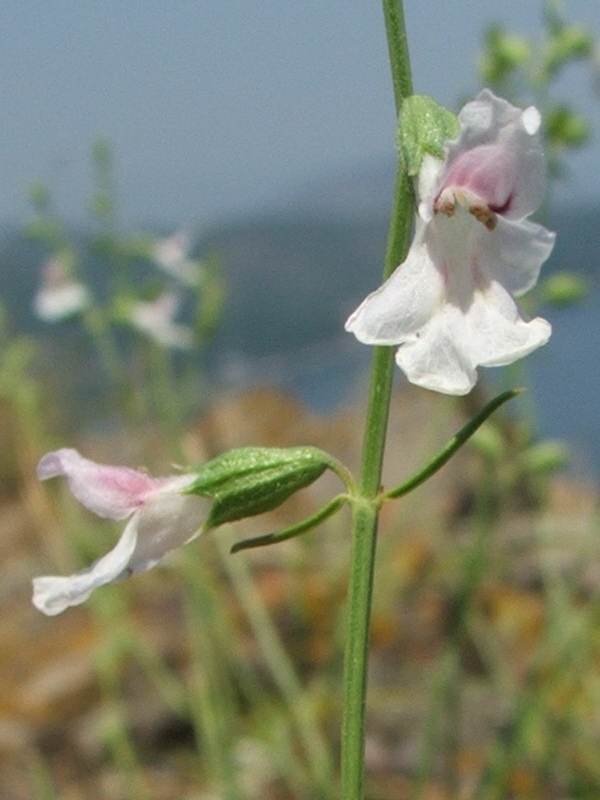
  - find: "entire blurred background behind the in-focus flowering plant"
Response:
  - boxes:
[0,0,600,800]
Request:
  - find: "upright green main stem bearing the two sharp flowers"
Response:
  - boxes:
[341,0,413,800]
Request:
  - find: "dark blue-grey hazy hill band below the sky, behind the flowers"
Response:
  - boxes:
[0,198,600,356]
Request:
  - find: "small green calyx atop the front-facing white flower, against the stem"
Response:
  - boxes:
[396,94,459,175]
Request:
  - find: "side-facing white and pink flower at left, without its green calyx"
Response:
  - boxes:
[33,448,208,616]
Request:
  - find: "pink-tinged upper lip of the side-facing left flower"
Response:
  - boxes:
[37,448,193,519]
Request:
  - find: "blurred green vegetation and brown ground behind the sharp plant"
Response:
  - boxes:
[0,2,600,800]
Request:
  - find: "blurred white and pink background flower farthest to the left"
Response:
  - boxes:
[33,257,91,322]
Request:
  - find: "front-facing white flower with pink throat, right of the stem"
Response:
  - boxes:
[346,89,555,395]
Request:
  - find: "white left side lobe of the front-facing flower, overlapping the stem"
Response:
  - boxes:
[345,230,443,345]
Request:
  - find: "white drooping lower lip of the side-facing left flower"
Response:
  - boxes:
[33,515,137,616]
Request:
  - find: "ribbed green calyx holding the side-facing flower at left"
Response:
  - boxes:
[187,447,332,529]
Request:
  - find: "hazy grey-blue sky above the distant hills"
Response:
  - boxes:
[0,0,600,226]
